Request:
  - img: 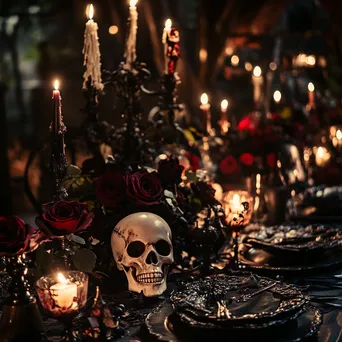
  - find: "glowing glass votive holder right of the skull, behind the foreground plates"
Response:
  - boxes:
[222,190,253,226]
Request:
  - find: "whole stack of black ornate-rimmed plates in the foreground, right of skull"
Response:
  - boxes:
[146,274,322,342]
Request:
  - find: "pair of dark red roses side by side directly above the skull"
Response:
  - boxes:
[96,170,163,208]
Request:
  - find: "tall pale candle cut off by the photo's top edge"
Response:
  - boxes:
[125,0,138,70]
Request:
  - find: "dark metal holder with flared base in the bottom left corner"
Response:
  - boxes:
[0,254,45,342]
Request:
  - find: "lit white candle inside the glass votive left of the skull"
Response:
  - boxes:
[50,273,77,308]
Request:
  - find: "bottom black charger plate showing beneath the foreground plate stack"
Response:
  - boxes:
[145,301,322,342]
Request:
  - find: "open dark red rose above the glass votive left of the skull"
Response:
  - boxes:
[36,201,94,236]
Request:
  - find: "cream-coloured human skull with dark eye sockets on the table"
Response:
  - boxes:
[111,212,173,297]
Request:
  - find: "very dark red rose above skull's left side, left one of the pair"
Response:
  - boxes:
[96,170,126,208]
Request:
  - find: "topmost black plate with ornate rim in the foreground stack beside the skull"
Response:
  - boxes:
[170,274,305,327]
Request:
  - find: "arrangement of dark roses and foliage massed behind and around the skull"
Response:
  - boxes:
[58,156,225,273]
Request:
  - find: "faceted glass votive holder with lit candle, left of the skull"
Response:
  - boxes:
[36,271,88,318]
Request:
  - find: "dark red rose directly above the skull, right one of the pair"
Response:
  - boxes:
[126,171,163,205]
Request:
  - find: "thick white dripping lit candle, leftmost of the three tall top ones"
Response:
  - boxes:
[82,4,103,90]
